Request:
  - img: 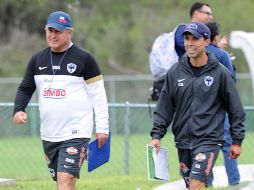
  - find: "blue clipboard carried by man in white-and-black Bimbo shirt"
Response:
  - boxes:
[87,132,111,172]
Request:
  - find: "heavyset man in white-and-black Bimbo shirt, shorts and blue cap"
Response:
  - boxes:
[13,11,109,190]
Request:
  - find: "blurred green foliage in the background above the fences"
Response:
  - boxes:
[0,0,254,77]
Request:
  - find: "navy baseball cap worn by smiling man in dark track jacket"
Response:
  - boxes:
[183,22,211,39]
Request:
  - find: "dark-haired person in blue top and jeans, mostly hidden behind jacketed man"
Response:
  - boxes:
[206,22,240,185]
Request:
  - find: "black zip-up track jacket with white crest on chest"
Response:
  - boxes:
[150,52,245,149]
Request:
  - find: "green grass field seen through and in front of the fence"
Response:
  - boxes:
[0,132,254,190]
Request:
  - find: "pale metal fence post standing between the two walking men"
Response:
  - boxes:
[124,102,130,175]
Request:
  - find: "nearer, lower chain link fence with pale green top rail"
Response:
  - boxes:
[0,102,254,180]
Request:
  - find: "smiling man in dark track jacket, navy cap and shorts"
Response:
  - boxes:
[150,22,245,190]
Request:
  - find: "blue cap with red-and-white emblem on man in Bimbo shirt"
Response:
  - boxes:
[46,11,72,32]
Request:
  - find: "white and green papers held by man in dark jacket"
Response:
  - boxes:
[146,145,169,181]
